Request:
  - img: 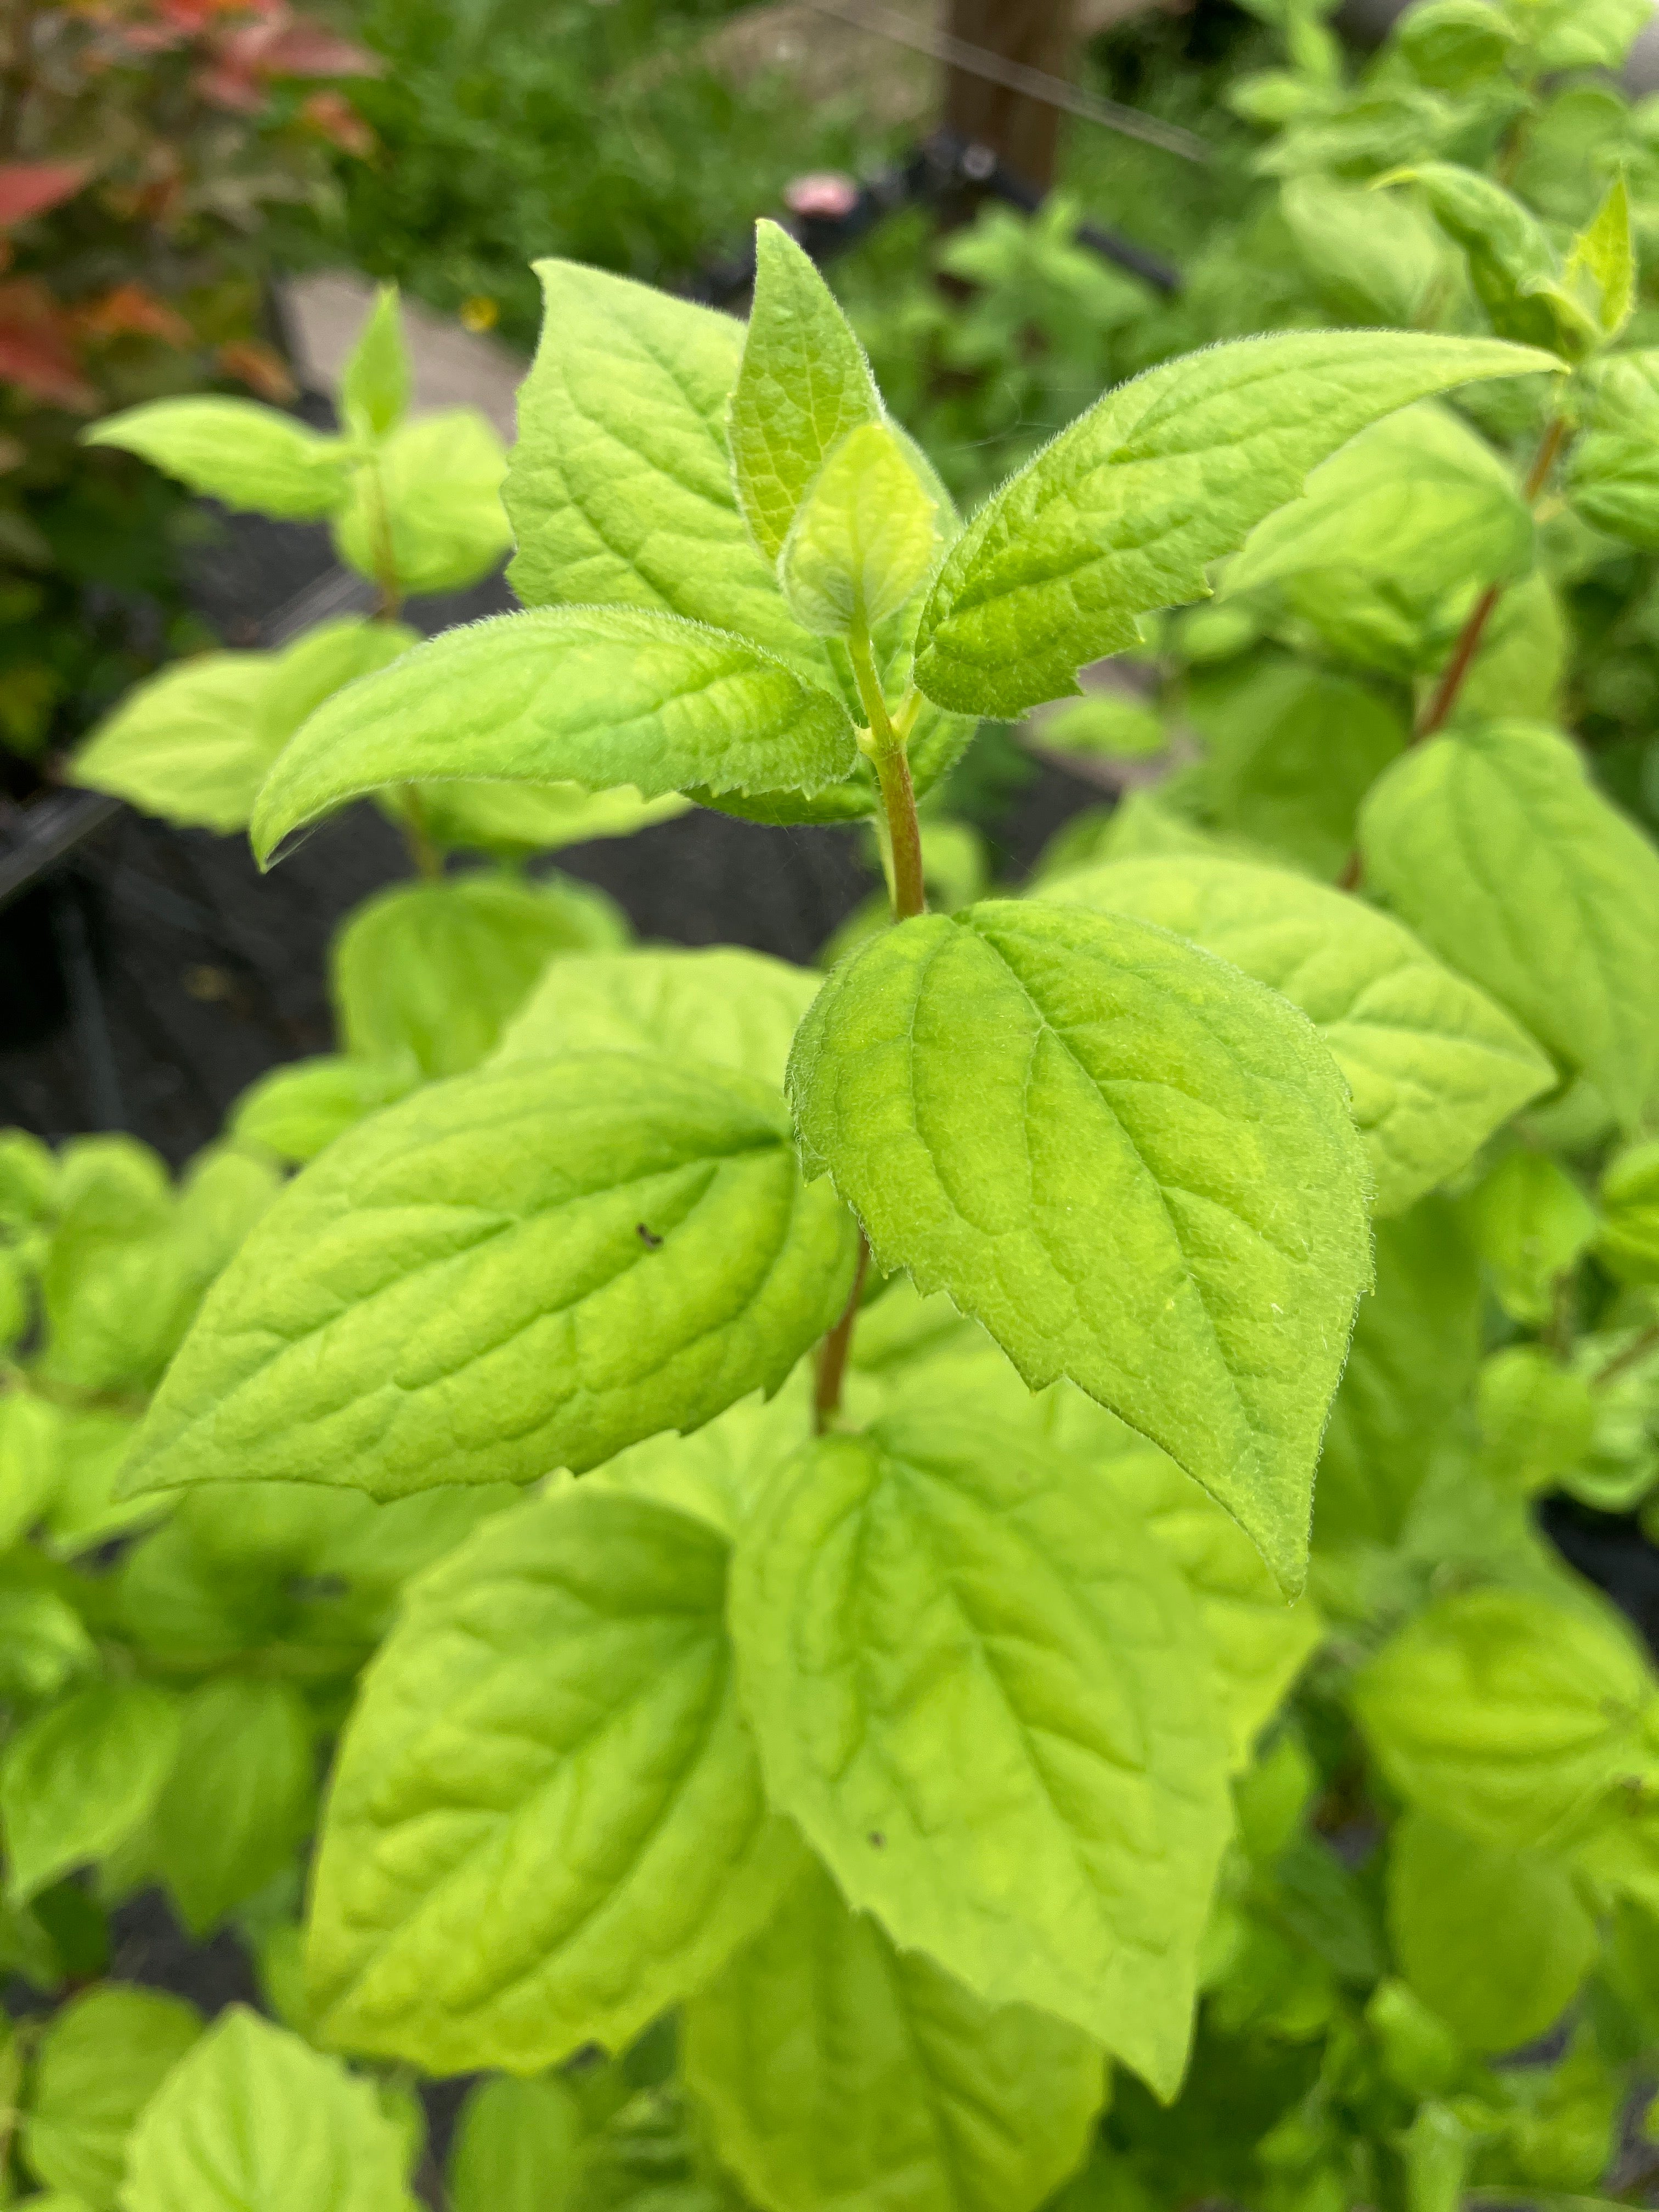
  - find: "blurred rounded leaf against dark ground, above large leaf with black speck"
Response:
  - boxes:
[330,872,628,1075]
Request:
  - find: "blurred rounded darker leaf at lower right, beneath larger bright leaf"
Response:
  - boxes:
[1389,1812,1601,2051]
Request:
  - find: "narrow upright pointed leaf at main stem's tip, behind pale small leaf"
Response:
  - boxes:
[728,223,884,566]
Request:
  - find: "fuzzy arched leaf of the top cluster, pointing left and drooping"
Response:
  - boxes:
[252,606,858,860]
